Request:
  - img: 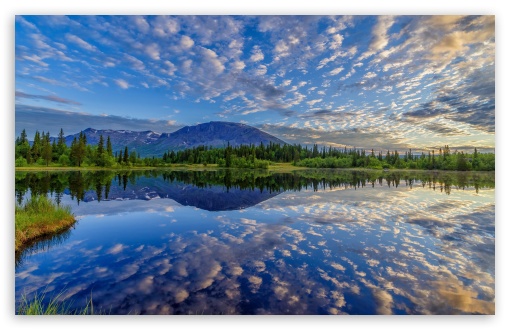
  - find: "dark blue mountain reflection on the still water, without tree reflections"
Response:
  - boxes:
[78,179,280,211]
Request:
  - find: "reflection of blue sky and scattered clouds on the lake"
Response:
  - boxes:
[16,178,495,314]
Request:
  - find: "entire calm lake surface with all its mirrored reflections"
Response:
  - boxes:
[15,170,495,315]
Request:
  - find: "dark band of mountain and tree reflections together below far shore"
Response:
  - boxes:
[15,169,495,211]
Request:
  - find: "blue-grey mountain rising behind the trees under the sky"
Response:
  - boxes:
[56,121,286,157]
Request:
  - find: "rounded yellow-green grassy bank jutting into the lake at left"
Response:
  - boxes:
[15,196,76,252]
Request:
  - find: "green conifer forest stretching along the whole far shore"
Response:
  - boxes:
[15,129,496,171]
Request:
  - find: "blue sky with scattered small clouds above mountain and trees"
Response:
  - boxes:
[15,15,495,151]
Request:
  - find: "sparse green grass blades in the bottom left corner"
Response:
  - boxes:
[16,292,100,315]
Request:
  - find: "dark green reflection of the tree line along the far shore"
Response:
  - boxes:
[15,170,495,204]
